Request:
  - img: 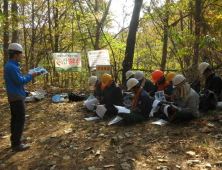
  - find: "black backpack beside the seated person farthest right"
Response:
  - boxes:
[199,90,217,110]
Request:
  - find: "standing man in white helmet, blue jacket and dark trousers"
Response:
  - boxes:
[4,43,37,151]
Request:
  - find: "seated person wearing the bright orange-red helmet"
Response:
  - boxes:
[149,70,173,97]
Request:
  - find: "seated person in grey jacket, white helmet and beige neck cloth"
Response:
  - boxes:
[163,75,199,122]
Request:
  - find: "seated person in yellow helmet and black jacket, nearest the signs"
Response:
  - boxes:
[98,74,123,118]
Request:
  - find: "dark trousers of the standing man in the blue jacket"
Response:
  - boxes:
[10,100,25,147]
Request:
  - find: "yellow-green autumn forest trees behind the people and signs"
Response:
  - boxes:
[0,0,222,87]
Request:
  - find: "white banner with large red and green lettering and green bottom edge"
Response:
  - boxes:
[53,52,82,72]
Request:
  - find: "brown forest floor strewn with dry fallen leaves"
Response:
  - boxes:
[0,80,222,170]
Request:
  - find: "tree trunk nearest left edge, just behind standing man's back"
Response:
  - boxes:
[3,0,9,74]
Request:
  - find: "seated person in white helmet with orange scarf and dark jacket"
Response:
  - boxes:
[118,78,152,124]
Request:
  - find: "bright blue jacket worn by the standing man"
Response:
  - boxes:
[4,59,33,102]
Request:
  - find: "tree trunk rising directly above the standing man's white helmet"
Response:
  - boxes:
[11,0,18,43]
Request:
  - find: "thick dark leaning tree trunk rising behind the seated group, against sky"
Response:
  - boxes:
[122,0,143,85]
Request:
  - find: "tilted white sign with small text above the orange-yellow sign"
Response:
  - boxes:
[88,50,110,69]
